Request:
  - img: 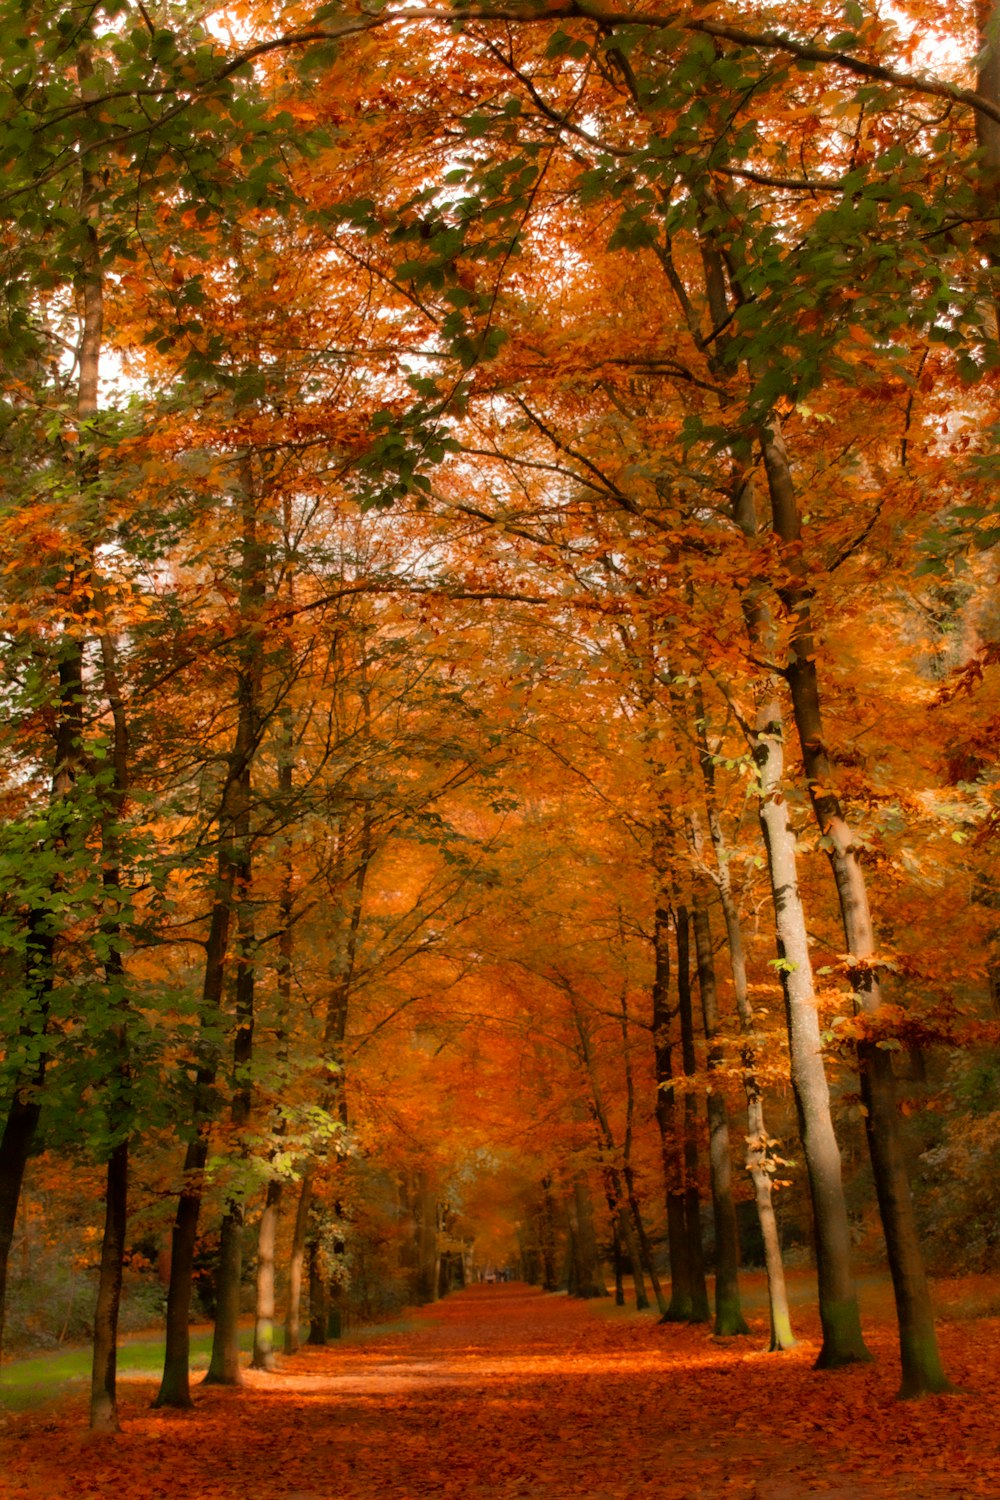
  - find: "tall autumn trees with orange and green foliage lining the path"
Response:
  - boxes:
[0,0,1000,1428]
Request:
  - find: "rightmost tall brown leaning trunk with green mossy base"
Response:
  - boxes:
[763,426,951,1397]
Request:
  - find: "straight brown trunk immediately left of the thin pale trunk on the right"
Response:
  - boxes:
[691,905,750,1335]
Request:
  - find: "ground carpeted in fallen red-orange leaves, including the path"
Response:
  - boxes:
[0,1284,1000,1500]
